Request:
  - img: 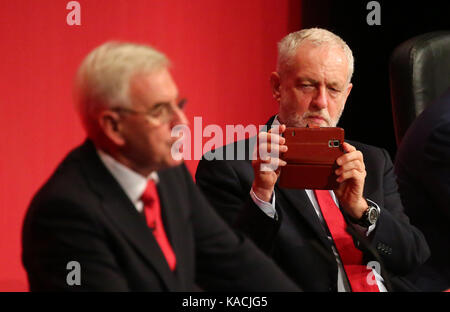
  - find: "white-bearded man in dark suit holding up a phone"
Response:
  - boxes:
[196,28,429,291]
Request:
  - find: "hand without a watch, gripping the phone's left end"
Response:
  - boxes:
[252,125,287,202]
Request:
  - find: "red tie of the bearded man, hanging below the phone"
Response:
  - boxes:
[314,190,380,292]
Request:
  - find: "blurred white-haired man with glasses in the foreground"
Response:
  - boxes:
[23,42,298,291]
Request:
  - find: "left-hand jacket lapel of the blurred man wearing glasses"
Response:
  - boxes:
[78,141,178,290]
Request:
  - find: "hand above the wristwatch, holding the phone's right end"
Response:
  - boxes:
[334,142,368,219]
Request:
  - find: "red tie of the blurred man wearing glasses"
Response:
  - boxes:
[141,180,177,271]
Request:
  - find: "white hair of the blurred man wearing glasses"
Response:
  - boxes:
[75,41,170,134]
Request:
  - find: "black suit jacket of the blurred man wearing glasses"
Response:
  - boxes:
[23,141,298,291]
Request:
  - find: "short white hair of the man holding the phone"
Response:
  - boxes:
[277,28,354,82]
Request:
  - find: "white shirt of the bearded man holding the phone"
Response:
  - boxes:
[250,116,387,292]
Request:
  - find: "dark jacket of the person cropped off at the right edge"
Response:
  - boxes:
[395,89,450,290]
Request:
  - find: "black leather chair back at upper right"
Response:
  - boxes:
[389,31,450,145]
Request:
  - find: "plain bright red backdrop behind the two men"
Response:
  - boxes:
[0,0,300,291]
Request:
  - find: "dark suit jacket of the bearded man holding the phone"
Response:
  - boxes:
[196,119,429,291]
